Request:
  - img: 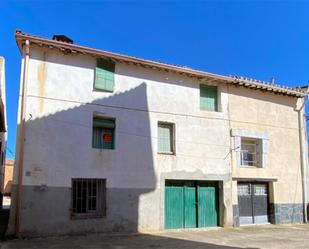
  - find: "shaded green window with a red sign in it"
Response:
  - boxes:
[92,117,115,150]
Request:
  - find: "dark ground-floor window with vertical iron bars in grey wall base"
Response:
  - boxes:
[72,178,105,217]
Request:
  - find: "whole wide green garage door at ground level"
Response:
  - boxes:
[165,181,219,229]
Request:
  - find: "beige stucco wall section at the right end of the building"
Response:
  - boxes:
[229,86,302,204]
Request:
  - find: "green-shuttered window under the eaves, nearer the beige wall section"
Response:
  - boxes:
[200,85,218,112]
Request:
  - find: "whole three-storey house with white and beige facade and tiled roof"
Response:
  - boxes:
[9,31,307,236]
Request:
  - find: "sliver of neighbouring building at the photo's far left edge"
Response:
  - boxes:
[0,56,7,209]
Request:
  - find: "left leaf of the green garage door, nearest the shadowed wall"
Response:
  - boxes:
[164,186,184,229]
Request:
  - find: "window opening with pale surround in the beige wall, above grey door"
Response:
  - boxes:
[240,138,262,167]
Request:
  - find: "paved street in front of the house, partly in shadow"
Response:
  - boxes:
[0,225,309,249]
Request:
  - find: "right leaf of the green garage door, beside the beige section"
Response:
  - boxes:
[197,183,219,227]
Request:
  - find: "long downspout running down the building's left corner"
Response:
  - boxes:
[15,40,30,236]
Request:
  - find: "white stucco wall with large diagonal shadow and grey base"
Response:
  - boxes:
[9,38,306,236]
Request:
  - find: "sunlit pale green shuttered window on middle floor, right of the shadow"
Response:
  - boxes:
[158,122,175,154]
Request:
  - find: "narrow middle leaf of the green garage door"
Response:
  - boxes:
[184,186,196,228]
